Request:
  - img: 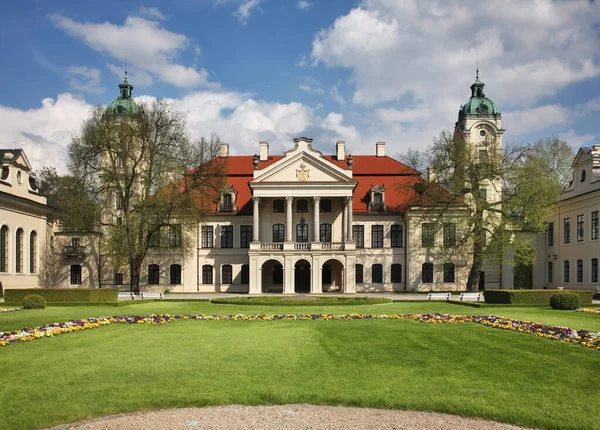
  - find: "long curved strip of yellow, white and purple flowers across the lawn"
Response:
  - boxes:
[0,313,600,350]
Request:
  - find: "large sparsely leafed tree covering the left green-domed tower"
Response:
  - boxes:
[68,100,226,293]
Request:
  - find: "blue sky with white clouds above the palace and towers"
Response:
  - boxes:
[0,0,600,171]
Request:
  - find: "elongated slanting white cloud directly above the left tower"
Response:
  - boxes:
[50,14,219,88]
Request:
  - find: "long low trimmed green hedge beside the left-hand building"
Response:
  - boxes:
[4,288,119,304]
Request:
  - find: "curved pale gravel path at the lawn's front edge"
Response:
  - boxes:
[51,405,523,430]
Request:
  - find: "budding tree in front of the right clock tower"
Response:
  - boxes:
[413,131,568,291]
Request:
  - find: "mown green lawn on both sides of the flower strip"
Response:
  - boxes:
[0,302,600,429]
